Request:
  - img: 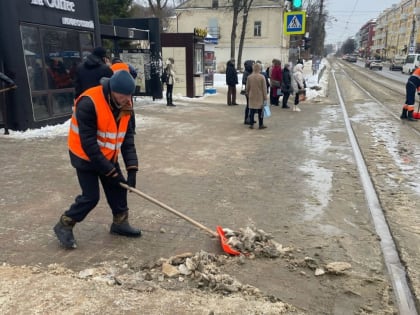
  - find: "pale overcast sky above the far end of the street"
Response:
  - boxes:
[324,0,400,44]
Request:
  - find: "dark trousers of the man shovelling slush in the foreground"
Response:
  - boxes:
[64,165,128,222]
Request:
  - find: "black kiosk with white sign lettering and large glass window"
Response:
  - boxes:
[0,0,100,130]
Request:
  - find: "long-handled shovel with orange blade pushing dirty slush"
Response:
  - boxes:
[120,183,241,255]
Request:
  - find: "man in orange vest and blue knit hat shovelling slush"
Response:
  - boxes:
[54,71,141,249]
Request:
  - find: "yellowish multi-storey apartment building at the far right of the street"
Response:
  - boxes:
[371,0,420,59]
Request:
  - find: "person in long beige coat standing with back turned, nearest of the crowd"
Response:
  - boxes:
[245,63,267,129]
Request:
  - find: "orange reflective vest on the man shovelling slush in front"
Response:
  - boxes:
[67,85,130,162]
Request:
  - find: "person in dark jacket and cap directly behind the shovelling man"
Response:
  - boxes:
[74,47,113,98]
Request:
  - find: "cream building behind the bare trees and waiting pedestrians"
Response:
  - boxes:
[167,0,289,68]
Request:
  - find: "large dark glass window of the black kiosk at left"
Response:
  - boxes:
[20,24,93,121]
